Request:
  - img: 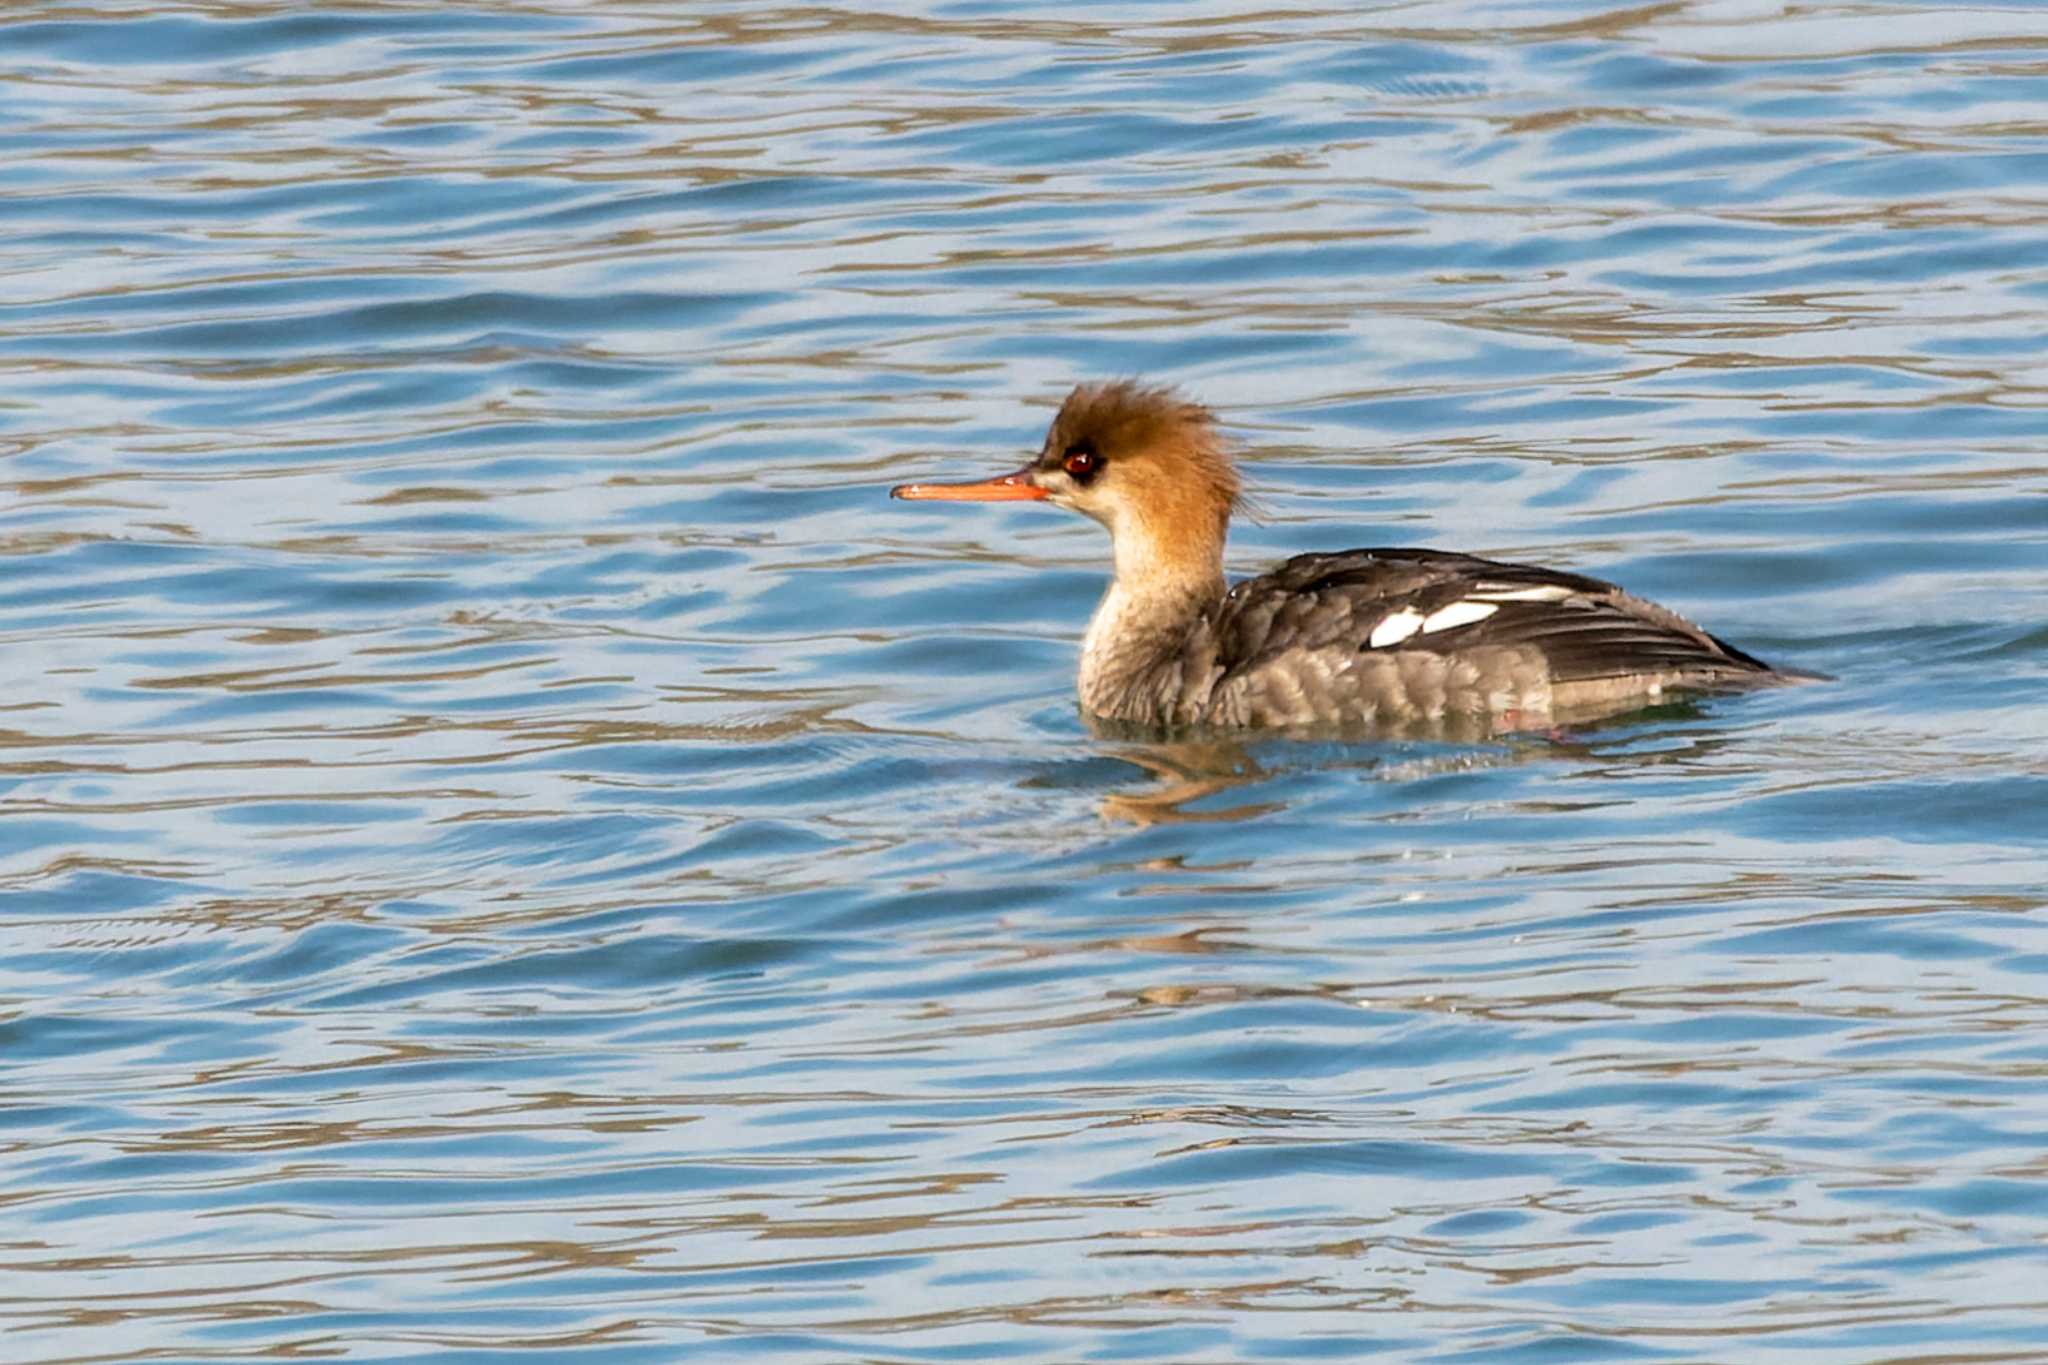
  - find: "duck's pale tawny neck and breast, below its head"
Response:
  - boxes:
[1079,515,1225,720]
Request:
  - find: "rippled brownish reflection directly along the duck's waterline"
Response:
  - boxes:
[1085,700,1726,827]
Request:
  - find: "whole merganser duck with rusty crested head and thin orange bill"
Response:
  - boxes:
[889,381,1812,729]
